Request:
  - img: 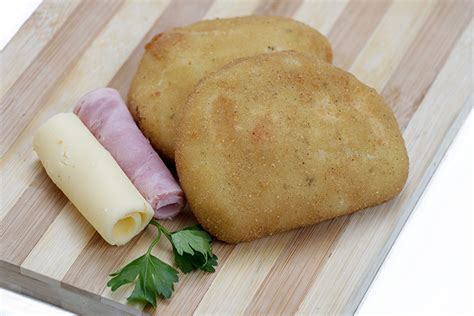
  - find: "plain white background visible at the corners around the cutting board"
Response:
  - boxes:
[0,0,474,316]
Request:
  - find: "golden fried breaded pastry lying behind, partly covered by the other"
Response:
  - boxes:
[128,16,332,159]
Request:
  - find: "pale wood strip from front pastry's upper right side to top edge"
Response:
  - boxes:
[350,0,436,92]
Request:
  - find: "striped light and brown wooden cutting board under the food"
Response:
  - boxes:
[0,0,473,315]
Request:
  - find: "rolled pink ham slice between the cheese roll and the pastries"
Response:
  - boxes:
[74,88,184,219]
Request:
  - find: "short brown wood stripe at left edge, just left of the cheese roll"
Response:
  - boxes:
[0,169,68,265]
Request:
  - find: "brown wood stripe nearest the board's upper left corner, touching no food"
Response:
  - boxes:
[0,0,122,156]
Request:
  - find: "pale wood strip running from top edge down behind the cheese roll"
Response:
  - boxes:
[0,0,169,222]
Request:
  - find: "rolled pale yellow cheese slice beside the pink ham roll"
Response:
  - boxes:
[33,113,153,245]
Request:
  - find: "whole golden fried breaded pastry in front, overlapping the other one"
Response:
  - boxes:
[176,52,408,243]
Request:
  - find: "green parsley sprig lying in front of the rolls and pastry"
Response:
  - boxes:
[107,220,217,307]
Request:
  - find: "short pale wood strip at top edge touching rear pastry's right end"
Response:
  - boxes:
[294,0,349,35]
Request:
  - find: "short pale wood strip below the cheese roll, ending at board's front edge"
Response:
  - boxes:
[21,203,95,281]
